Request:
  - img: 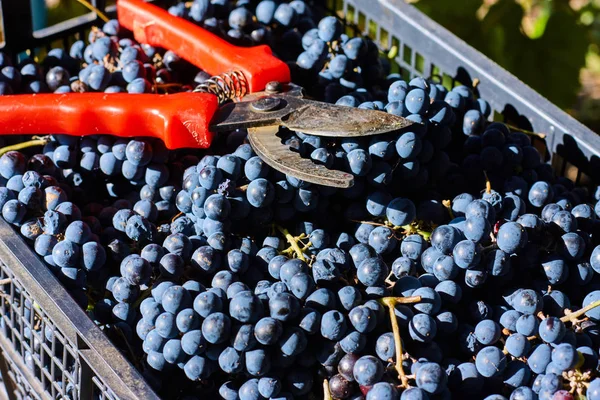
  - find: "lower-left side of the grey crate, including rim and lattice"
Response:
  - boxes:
[0,219,158,399]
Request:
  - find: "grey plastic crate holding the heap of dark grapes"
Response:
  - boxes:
[0,0,600,399]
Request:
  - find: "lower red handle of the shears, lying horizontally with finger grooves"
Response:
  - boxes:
[0,93,218,149]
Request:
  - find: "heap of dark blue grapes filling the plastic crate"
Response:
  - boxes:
[0,0,600,400]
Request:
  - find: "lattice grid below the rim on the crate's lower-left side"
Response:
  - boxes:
[0,256,115,399]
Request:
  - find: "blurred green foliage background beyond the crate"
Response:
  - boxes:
[38,0,600,132]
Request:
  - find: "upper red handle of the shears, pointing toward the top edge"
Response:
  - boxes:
[117,0,290,92]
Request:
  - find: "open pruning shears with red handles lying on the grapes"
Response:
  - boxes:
[0,0,412,187]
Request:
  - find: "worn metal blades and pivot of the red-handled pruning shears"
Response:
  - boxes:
[211,93,413,188]
